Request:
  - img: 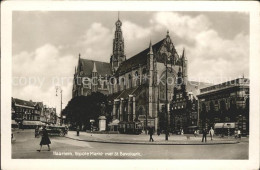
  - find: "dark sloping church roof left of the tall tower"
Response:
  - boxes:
[80,58,112,76]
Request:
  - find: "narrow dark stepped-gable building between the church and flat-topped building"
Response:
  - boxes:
[171,64,210,133]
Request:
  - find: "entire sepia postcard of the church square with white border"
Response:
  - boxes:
[1,2,259,169]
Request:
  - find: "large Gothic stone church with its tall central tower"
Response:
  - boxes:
[72,16,211,130]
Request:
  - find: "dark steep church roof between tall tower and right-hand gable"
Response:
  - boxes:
[117,39,165,73]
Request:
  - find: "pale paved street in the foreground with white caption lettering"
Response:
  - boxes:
[12,130,248,159]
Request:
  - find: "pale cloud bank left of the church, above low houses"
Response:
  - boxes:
[12,44,77,113]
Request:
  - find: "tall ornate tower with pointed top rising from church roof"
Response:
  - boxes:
[110,14,126,73]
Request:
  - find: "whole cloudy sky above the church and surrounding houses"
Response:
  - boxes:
[12,11,249,112]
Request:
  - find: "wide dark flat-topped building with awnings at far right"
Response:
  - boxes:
[198,78,250,134]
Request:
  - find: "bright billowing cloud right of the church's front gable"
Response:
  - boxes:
[150,12,249,83]
